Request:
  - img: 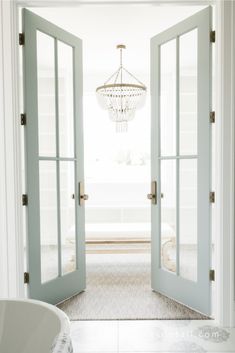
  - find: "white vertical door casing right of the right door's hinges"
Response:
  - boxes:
[214,0,235,327]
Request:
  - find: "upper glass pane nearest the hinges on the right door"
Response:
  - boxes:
[179,29,198,155]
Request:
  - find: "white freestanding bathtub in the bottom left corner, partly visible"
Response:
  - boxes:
[0,299,73,353]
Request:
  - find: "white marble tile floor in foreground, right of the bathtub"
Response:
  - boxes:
[71,320,235,353]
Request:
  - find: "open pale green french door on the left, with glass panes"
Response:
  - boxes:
[23,9,86,304]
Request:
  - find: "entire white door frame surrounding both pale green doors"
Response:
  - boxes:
[0,0,235,327]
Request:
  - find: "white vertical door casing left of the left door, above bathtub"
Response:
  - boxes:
[0,1,23,297]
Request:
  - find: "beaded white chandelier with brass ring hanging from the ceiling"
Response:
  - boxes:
[96,44,147,132]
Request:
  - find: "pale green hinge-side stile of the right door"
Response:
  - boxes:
[198,8,212,305]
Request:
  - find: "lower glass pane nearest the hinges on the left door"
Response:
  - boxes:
[39,161,58,282]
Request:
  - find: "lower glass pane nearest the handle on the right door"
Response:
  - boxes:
[161,160,176,272]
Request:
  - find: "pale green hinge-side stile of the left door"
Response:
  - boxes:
[22,11,41,295]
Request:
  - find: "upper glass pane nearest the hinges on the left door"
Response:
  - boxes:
[37,31,56,157]
